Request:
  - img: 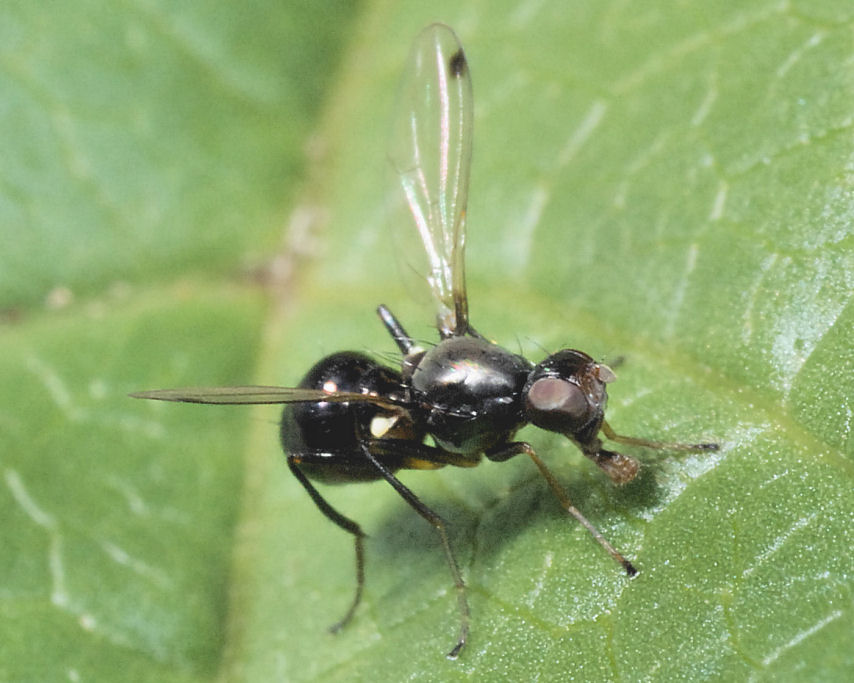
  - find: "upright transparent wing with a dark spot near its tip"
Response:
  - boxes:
[390,24,473,338]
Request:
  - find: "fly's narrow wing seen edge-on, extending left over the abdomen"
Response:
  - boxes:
[130,386,400,408]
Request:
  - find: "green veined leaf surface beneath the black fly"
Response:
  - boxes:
[0,0,854,681]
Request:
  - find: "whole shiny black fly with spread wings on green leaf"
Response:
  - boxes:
[131,24,718,658]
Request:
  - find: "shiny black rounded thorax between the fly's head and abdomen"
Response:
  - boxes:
[410,336,532,454]
